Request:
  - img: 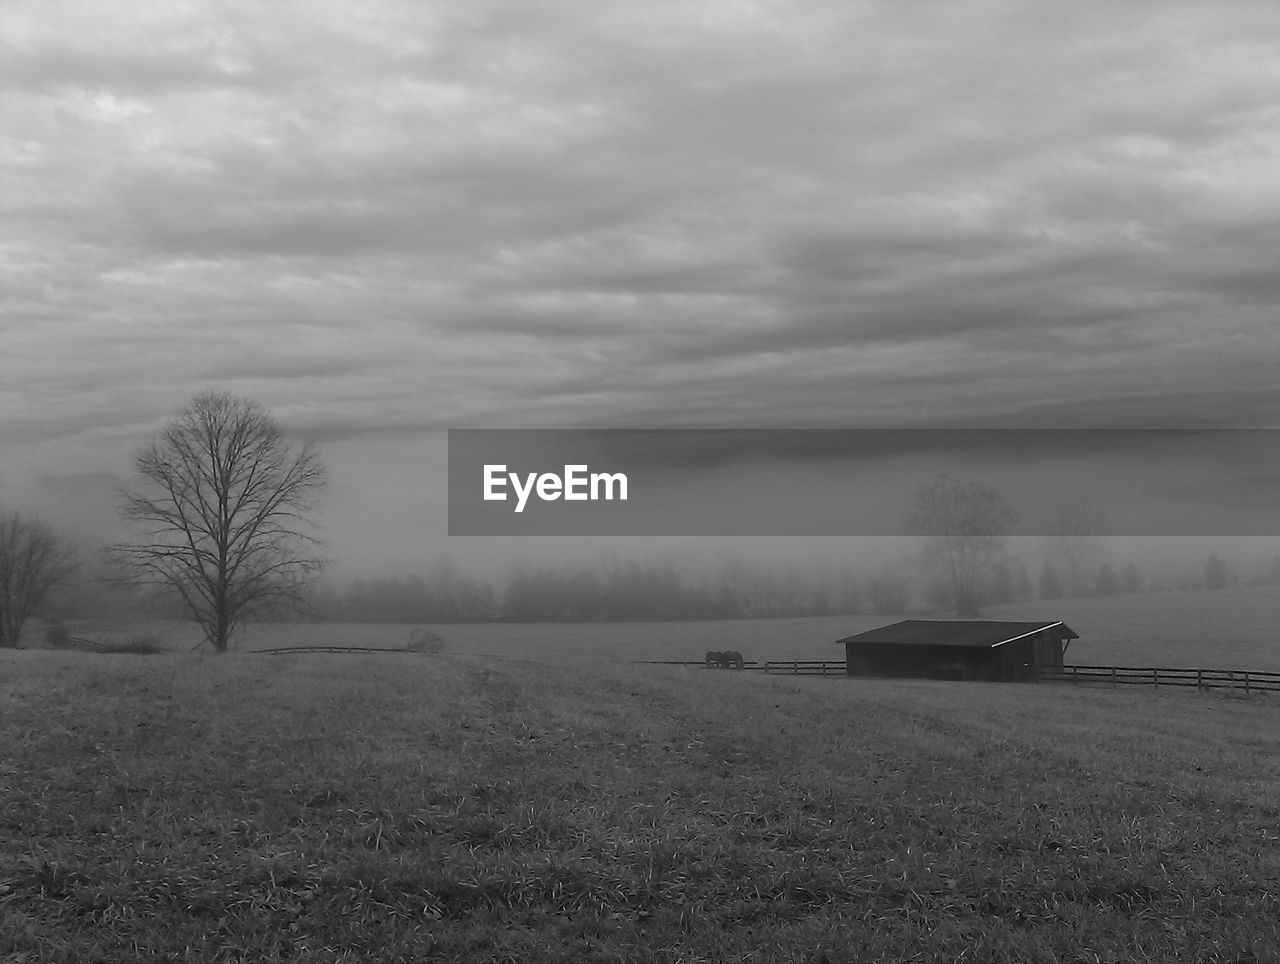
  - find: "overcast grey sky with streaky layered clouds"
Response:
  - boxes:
[0,0,1280,570]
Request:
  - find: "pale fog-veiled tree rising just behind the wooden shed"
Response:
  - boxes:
[906,475,1018,616]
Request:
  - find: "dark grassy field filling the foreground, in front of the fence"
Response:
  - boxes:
[0,642,1280,964]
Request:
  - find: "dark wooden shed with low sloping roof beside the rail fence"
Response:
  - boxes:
[837,620,1079,681]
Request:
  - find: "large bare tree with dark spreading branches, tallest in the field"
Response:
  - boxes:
[109,393,328,653]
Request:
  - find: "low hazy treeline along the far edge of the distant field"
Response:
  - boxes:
[299,553,1280,623]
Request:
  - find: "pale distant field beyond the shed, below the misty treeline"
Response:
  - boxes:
[49,586,1280,672]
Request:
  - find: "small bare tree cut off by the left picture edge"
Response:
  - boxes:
[0,512,74,648]
